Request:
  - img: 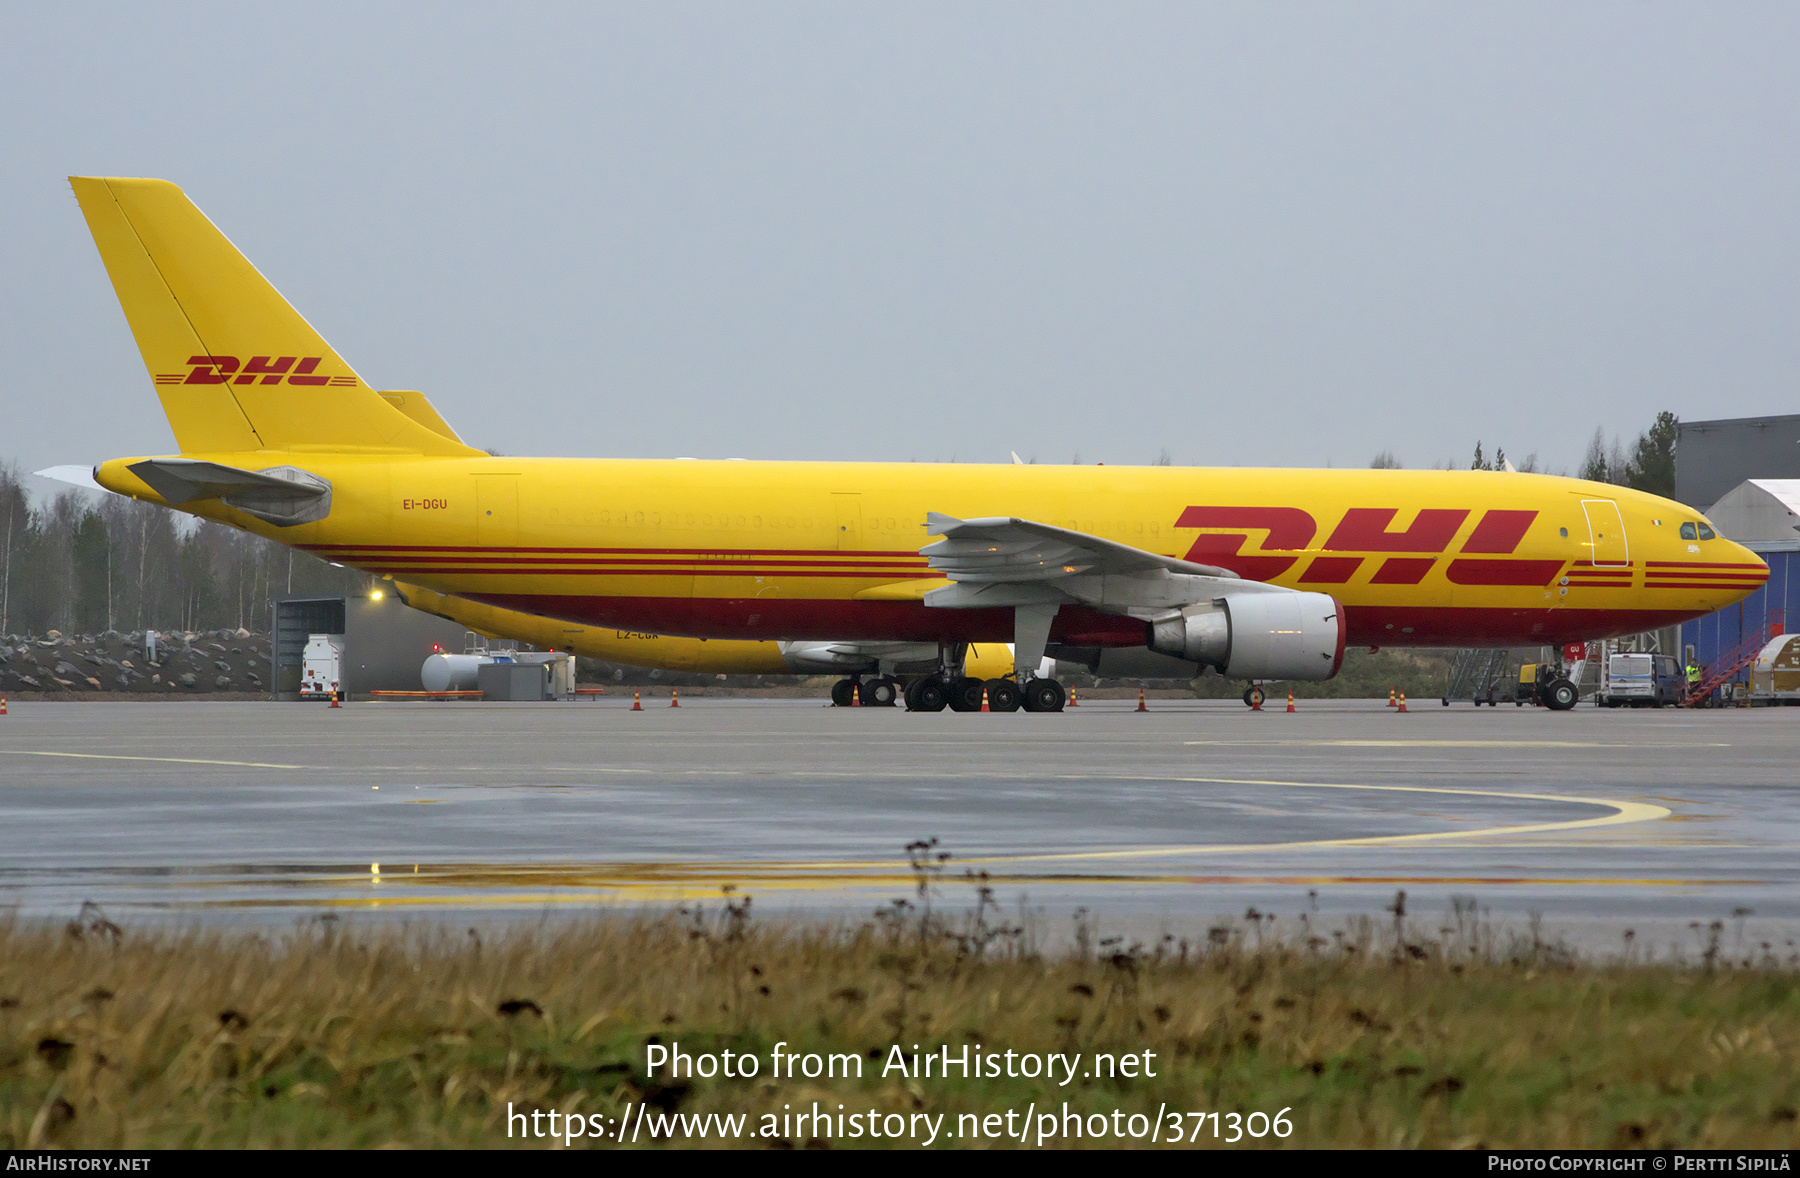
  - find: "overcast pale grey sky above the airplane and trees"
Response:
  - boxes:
[0,0,1800,493]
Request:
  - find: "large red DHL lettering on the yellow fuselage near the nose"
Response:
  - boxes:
[1175,506,1562,585]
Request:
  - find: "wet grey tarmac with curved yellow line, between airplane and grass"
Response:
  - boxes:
[0,697,1800,949]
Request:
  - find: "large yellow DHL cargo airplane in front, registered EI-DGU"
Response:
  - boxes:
[70,177,1768,711]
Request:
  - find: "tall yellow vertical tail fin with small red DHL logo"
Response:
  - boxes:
[68,177,479,456]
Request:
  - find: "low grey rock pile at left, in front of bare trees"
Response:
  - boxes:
[0,630,270,695]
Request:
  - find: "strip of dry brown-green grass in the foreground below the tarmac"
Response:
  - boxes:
[0,908,1800,1147]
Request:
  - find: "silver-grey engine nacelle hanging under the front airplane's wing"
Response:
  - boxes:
[1150,593,1345,679]
